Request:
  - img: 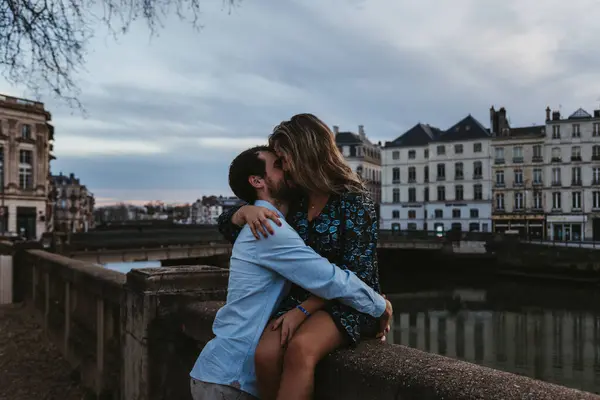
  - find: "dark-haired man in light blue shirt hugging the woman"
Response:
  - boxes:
[190,146,392,400]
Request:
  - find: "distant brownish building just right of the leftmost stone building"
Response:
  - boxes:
[52,173,95,233]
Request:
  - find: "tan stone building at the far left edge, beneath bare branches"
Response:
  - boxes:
[0,95,54,239]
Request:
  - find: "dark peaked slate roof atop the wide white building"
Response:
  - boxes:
[385,114,492,147]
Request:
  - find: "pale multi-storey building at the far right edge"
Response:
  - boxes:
[543,107,600,241]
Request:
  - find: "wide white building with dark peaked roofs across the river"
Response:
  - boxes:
[380,115,492,232]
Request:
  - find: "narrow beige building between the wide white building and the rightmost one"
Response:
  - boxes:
[490,107,547,238]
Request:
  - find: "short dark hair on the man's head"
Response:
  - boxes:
[229,146,270,204]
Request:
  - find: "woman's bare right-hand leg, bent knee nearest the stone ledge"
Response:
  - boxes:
[277,311,349,400]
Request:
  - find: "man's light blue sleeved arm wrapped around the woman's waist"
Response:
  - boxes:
[255,221,386,318]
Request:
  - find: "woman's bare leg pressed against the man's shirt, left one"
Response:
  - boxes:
[254,320,285,400]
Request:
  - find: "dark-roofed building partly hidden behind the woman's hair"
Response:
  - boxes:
[333,125,381,204]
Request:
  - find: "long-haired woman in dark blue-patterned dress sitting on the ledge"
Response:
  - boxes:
[219,114,380,399]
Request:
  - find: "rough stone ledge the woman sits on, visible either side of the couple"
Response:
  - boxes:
[179,301,600,400]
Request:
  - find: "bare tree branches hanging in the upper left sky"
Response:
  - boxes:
[0,0,239,107]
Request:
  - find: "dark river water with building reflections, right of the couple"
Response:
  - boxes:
[384,275,600,393]
